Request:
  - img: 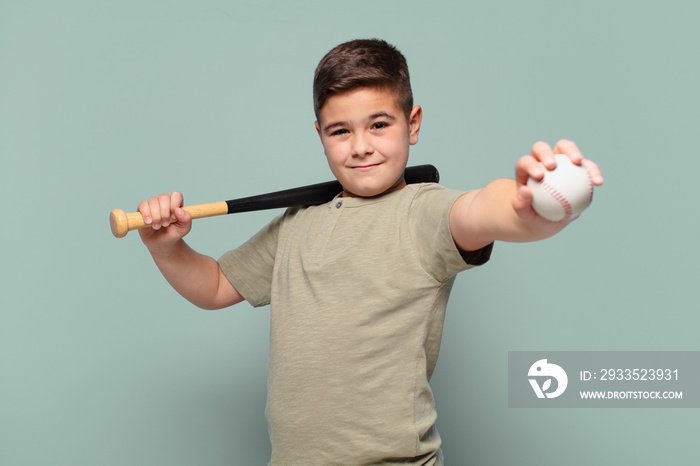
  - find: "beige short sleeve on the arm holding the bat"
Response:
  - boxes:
[219,215,283,307]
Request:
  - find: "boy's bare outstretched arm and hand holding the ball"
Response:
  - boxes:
[450,140,603,251]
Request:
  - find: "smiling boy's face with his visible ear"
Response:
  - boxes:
[316,88,422,197]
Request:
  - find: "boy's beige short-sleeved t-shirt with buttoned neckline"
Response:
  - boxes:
[219,184,491,466]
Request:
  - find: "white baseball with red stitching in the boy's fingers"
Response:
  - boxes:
[527,154,593,222]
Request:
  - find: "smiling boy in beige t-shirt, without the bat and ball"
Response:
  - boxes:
[139,40,602,465]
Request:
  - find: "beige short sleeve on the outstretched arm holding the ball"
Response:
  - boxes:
[409,184,493,282]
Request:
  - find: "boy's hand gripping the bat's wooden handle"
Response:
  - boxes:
[138,191,192,252]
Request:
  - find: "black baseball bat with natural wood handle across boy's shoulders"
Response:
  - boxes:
[109,165,440,238]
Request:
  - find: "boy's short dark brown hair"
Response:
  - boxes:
[314,39,413,120]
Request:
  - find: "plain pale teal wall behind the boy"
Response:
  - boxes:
[0,0,700,466]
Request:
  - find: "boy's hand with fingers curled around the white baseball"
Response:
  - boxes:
[513,139,603,223]
